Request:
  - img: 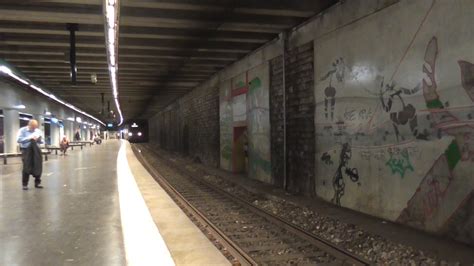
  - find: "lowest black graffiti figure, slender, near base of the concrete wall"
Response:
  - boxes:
[331,143,359,206]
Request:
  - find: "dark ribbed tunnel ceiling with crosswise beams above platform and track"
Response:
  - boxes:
[0,0,337,119]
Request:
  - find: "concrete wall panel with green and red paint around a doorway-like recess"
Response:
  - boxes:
[220,65,271,183]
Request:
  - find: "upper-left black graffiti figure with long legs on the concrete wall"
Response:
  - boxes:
[321,57,345,120]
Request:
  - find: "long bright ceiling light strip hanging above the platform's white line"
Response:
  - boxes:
[103,0,123,126]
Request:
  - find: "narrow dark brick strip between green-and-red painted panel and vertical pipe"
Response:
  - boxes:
[270,56,284,187]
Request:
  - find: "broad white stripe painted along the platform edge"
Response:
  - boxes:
[117,140,175,266]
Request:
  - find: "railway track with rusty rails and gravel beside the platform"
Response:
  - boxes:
[132,144,369,265]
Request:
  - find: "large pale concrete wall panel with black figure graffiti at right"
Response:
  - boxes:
[314,0,474,243]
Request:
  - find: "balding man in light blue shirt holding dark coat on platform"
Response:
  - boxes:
[17,119,43,190]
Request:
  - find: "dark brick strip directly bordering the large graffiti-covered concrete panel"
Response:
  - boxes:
[285,42,315,195]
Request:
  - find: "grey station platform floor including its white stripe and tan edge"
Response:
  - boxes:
[0,140,229,265]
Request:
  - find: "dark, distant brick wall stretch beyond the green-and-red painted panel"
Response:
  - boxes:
[151,84,219,167]
